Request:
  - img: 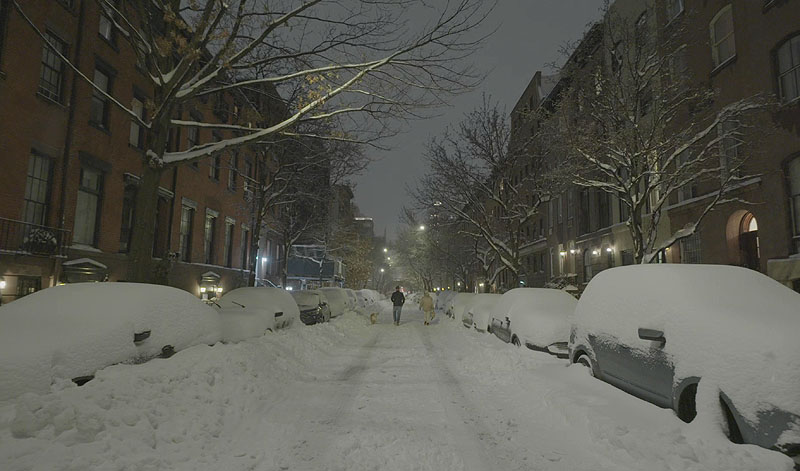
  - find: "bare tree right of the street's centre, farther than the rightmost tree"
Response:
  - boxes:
[412,99,558,285]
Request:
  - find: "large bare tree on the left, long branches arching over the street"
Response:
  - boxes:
[12,0,491,281]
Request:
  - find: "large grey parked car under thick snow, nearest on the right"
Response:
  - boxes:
[569,264,800,455]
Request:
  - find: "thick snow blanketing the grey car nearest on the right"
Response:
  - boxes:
[574,265,800,452]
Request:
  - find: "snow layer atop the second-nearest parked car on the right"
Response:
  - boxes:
[492,288,578,347]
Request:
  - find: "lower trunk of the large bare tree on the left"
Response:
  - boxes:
[128,165,165,283]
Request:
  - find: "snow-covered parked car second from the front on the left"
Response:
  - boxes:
[215,287,300,342]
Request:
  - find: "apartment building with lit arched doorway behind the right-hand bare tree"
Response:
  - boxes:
[504,0,800,289]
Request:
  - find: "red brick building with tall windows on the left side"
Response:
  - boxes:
[0,0,280,302]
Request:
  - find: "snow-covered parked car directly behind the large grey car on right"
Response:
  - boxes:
[492,288,578,358]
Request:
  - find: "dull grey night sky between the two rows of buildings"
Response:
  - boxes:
[353,0,603,242]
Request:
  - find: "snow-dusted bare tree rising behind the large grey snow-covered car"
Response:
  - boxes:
[548,4,767,263]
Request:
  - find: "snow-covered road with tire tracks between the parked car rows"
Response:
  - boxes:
[0,305,791,471]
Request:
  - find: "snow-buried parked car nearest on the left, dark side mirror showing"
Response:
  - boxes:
[0,283,220,400]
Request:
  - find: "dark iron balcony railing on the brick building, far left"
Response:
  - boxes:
[0,218,69,257]
